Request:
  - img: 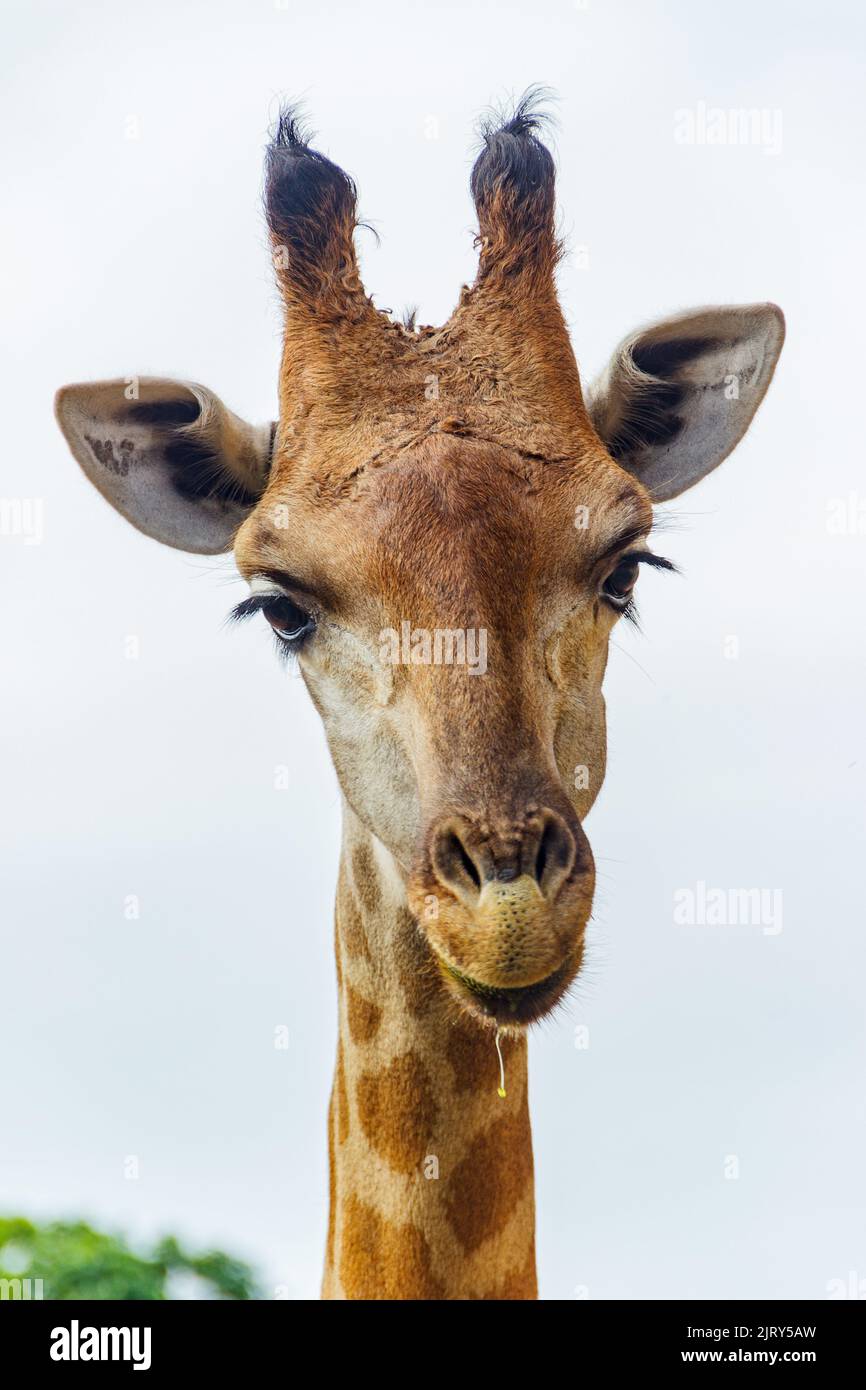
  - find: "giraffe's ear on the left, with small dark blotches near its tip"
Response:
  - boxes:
[54,377,274,555]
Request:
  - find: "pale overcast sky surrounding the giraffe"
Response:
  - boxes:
[0,0,866,1298]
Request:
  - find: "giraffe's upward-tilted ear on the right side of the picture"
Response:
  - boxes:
[587,304,785,502]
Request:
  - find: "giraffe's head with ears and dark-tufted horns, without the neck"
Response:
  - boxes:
[57,104,784,1026]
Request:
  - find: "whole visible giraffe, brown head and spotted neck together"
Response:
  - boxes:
[56,97,784,1300]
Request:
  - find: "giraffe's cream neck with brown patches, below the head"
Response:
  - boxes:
[322,808,537,1298]
